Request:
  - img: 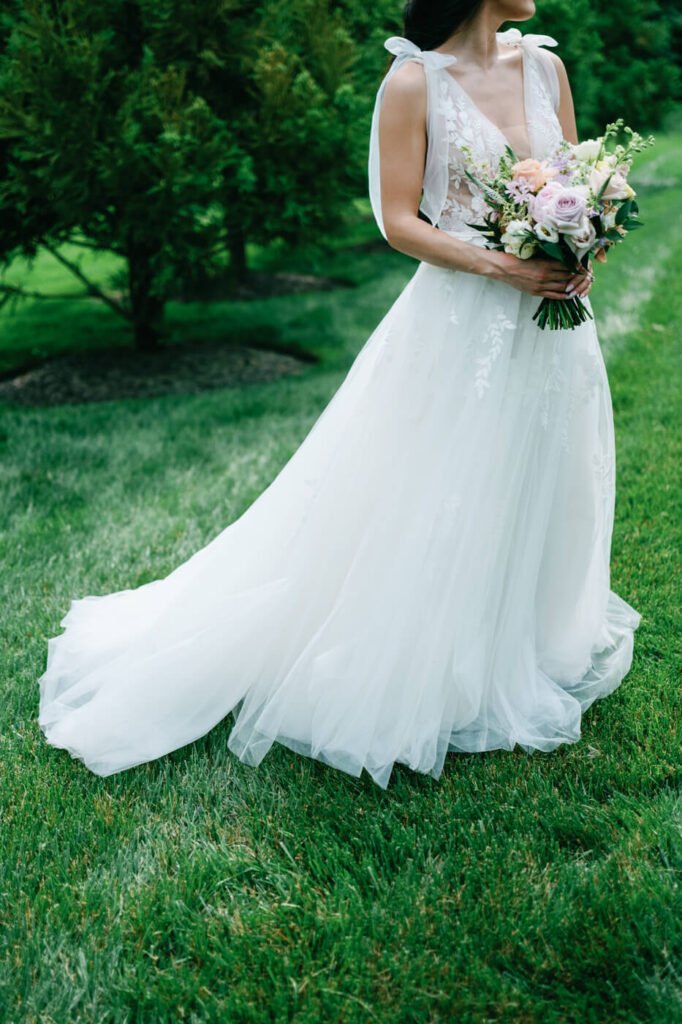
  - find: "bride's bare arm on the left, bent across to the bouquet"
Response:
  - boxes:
[379,61,571,299]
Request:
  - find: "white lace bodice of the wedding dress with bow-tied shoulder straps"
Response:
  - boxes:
[370,29,562,245]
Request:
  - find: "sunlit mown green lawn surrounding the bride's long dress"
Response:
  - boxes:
[0,137,682,1024]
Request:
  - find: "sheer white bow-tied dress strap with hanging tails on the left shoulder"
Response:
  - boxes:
[369,36,457,238]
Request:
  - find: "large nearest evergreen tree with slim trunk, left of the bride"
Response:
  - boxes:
[0,0,361,348]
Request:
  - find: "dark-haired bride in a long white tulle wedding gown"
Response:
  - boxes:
[39,0,640,787]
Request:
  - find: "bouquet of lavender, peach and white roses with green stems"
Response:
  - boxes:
[462,118,653,330]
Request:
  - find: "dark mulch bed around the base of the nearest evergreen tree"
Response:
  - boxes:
[0,342,306,406]
